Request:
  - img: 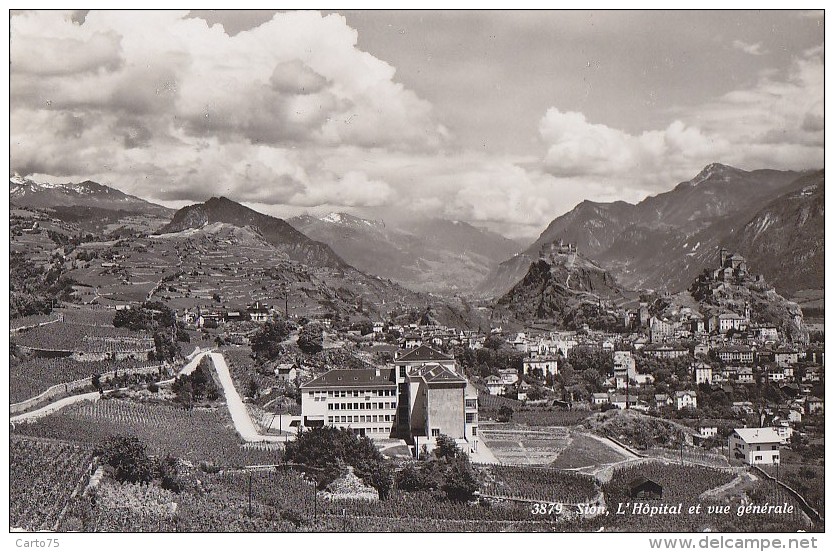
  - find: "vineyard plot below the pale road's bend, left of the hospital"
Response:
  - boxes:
[14,399,281,466]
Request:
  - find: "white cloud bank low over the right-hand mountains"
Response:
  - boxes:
[539,49,825,193]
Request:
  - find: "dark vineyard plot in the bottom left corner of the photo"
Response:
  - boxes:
[9,436,92,531]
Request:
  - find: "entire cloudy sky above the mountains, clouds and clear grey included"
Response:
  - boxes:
[10,11,824,238]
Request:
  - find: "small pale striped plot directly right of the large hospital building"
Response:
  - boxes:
[480,426,570,465]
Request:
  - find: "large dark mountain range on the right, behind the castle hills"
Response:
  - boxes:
[478,163,825,297]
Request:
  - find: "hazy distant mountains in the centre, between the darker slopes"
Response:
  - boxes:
[287,213,520,295]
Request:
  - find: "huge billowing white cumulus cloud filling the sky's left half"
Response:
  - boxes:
[11,11,445,206]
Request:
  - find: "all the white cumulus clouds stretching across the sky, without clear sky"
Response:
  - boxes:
[10,11,825,237]
